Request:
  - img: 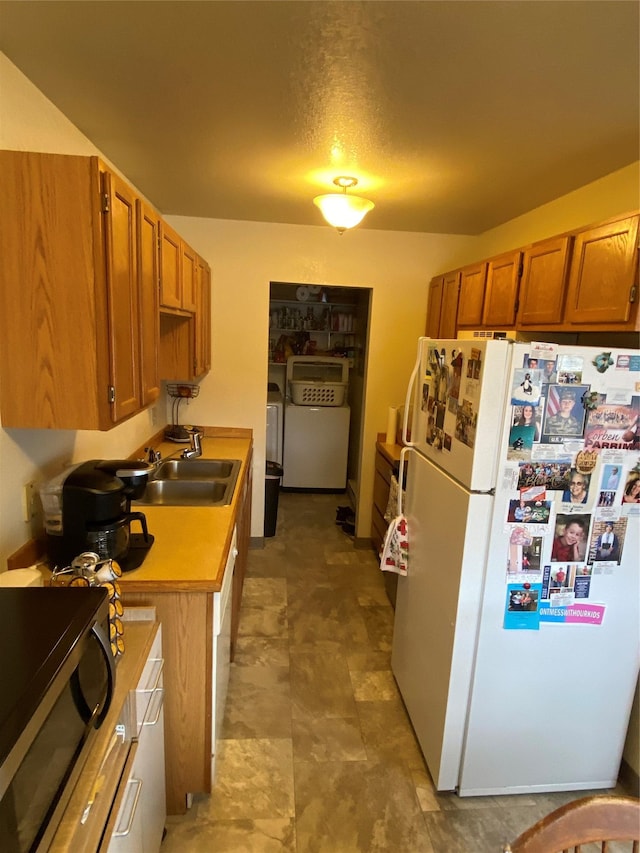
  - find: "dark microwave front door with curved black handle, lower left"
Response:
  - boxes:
[0,622,115,853]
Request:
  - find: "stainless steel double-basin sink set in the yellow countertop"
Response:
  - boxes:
[135,457,240,506]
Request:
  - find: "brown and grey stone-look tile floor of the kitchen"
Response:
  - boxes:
[161,493,627,853]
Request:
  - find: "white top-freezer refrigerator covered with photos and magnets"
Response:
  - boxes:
[392,338,640,796]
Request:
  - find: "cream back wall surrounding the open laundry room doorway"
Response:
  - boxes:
[160,216,468,536]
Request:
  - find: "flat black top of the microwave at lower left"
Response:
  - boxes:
[0,587,107,764]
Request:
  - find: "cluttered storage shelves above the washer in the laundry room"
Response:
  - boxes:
[269,299,358,364]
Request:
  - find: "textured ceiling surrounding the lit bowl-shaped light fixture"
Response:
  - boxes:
[0,0,640,234]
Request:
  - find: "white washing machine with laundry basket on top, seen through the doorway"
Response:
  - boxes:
[282,356,351,491]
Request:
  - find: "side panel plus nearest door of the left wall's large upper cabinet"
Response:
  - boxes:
[0,151,158,430]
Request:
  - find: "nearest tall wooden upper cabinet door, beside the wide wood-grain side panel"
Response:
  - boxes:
[103,172,142,423]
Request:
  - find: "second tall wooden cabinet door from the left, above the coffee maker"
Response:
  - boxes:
[137,205,160,406]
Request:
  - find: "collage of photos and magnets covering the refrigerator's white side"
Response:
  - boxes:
[504,343,640,630]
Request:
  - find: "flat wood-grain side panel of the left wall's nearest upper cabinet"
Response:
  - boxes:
[0,151,102,429]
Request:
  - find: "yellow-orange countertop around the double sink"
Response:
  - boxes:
[120,429,252,592]
